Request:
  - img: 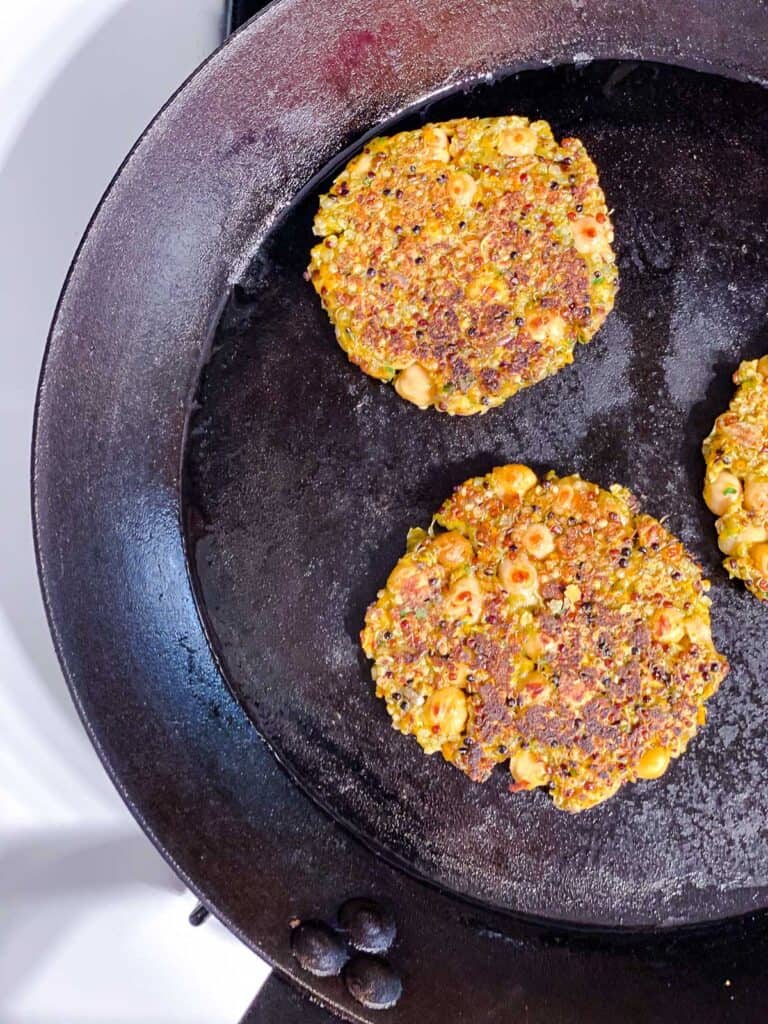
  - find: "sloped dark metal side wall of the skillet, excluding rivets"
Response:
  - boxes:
[34,0,766,1024]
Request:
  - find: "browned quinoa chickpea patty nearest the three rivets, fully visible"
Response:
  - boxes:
[361,466,728,811]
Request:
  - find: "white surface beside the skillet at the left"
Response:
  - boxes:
[0,0,267,1024]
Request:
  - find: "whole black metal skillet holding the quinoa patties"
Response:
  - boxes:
[34,0,768,1024]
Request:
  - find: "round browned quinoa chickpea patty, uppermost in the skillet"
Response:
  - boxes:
[308,117,617,414]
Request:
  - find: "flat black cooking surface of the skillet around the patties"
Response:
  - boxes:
[185,62,768,926]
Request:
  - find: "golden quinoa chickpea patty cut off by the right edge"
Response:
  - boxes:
[703,355,768,601]
